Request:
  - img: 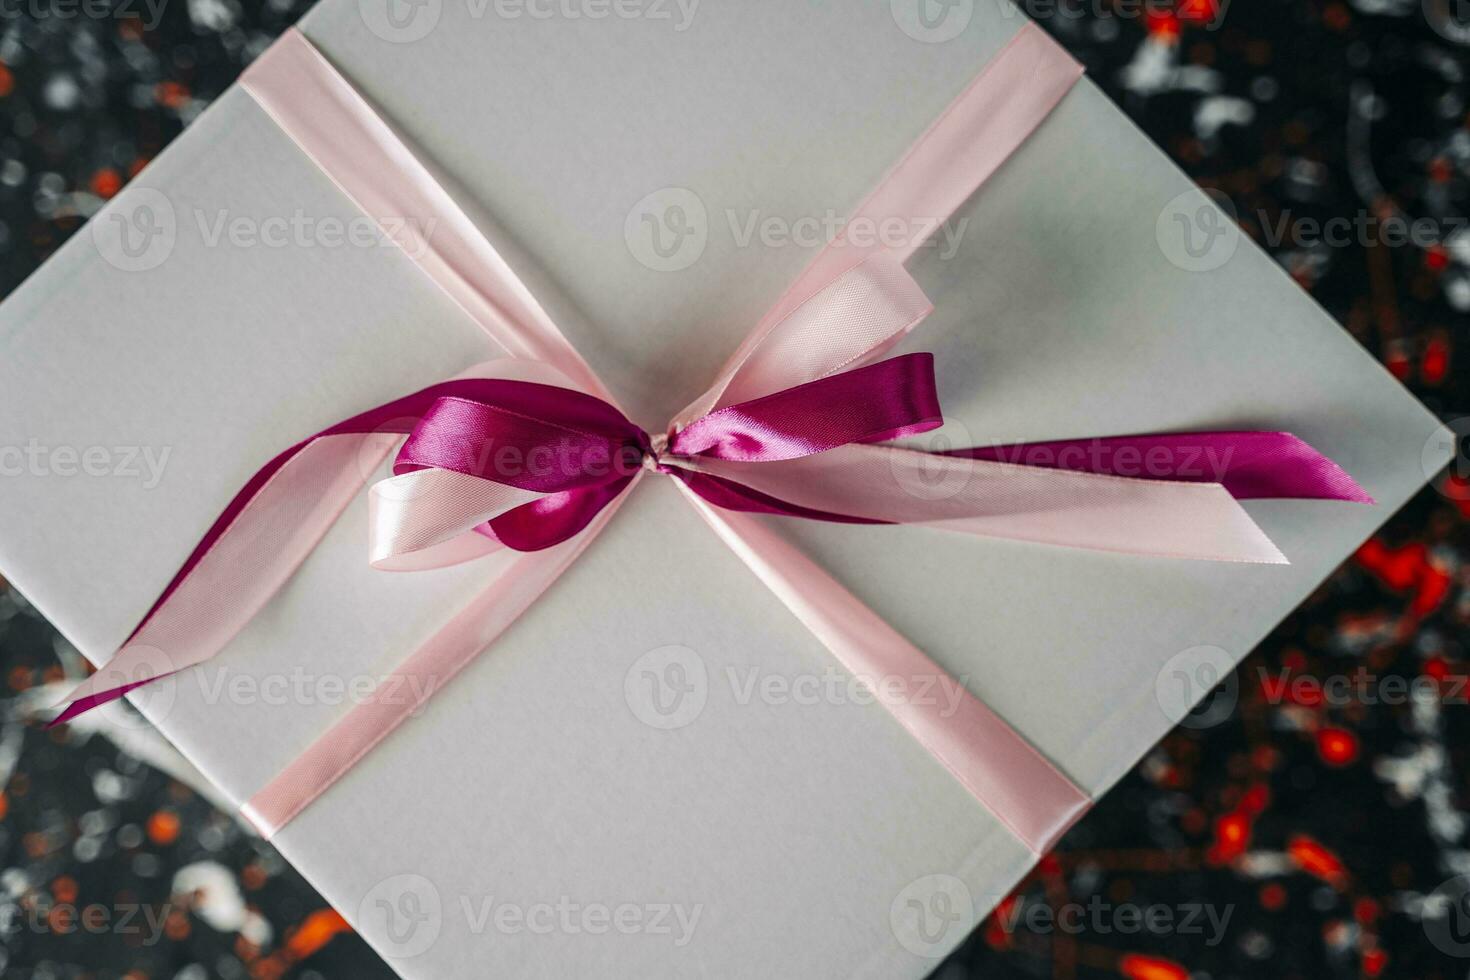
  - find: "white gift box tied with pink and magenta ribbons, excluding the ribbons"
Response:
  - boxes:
[0,0,1444,980]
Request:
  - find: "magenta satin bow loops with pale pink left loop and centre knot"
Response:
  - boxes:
[370,354,942,570]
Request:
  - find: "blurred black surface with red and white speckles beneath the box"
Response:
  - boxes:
[0,0,1470,980]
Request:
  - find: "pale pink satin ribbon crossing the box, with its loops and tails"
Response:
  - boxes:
[54,24,1361,854]
